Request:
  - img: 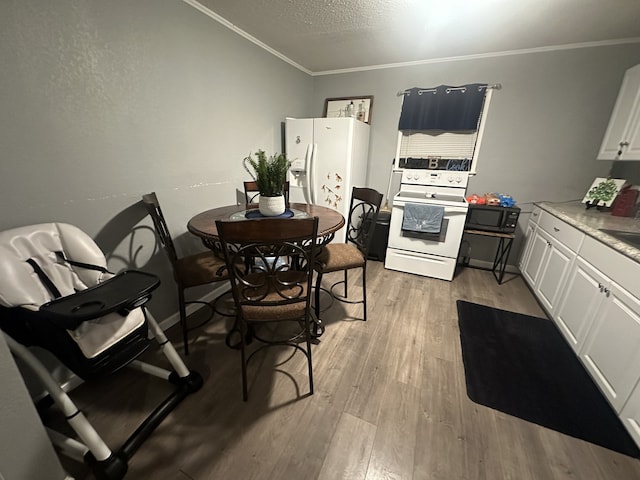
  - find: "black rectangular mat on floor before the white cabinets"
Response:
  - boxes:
[457,300,640,457]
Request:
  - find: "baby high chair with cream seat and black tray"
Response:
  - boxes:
[0,223,202,480]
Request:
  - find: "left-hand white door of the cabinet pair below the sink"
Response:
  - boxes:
[555,257,609,353]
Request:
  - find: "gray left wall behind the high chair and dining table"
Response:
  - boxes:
[0,0,313,320]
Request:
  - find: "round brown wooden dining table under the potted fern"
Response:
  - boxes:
[187,203,345,252]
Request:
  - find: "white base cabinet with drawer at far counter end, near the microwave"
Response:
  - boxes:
[522,212,584,316]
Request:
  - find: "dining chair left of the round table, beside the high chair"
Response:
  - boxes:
[142,192,229,355]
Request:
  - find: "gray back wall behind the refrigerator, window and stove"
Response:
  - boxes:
[313,43,640,264]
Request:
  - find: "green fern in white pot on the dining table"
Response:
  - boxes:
[243,150,291,217]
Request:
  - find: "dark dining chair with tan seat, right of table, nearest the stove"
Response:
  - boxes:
[315,187,382,321]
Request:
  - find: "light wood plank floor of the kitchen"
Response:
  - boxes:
[52,262,640,480]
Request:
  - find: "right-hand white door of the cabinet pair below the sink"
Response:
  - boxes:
[580,282,640,412]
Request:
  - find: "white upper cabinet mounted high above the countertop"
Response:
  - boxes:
[598,65,640,160]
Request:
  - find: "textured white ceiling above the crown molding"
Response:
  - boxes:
[194,0,640,73]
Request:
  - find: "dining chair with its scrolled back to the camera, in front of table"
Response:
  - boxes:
[216,217,318,401]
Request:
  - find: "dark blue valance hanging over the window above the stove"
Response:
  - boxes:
[398,83,487,132]
